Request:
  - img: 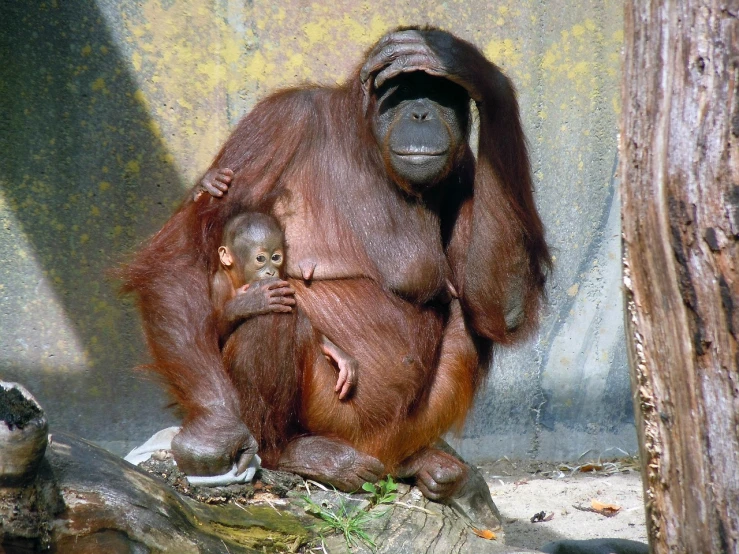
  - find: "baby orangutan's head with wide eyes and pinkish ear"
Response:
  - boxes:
[218,226,285,286]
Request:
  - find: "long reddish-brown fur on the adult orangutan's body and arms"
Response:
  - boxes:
[125,28,549,469]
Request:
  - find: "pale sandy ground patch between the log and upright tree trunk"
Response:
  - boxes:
[481,460,647,550]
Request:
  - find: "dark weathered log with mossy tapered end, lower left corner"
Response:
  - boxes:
[0,433,310,554]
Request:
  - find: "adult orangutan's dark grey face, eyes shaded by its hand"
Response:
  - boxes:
[373,71,469,192]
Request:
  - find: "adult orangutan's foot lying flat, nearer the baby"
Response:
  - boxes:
[277,436,385,492]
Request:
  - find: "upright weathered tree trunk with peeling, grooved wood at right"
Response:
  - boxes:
[620,0,739,553]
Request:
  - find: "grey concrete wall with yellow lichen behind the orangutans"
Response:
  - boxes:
[0,0,636,459]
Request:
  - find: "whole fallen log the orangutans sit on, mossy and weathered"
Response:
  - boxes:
[0,380,527,554]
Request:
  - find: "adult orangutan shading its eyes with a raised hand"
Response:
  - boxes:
[126,28,549,524]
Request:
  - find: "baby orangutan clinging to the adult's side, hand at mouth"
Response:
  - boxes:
[211,212,358,467]
